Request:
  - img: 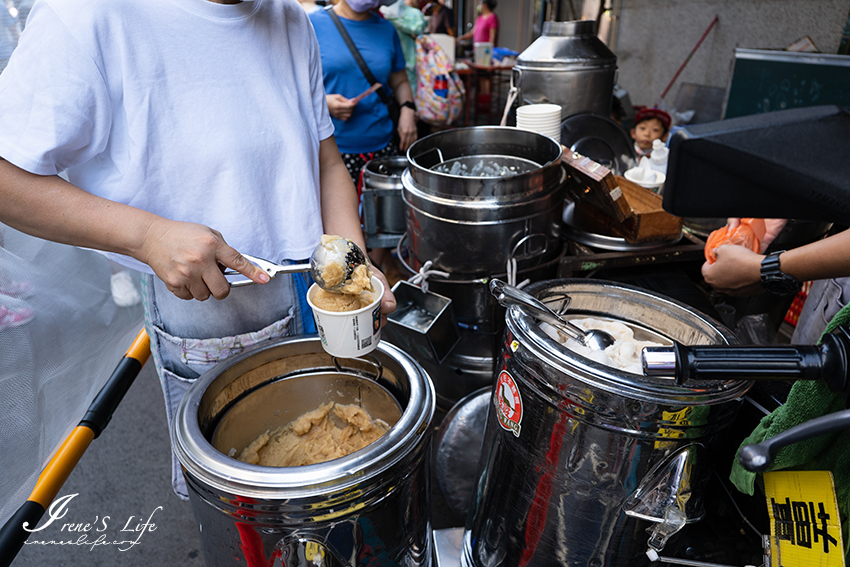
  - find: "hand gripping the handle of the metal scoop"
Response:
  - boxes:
[137,219,269,301]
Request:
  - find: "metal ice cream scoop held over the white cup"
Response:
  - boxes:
[224,236,366,291]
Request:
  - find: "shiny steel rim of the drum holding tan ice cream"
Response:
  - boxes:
[171,336,435,499]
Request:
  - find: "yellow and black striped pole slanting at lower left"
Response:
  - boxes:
[0,329,151,567]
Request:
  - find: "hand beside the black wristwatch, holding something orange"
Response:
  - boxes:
[702,244,764,297]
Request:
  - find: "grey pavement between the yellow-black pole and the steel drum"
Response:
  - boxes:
[12,361,204,567]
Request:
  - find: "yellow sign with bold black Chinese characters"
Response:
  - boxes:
[764,471,844,567]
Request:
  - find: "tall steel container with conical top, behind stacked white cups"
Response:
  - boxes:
[511,20,617,119]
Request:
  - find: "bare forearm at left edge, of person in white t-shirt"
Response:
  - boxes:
[0,159,160,259]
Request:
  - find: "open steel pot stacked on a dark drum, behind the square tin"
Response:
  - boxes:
[394,126,566,409]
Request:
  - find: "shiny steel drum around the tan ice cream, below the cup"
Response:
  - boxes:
[171,337,435,567]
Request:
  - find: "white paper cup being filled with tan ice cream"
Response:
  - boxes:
[307,276,384,358]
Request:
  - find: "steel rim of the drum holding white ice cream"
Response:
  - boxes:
[506,279,752,405]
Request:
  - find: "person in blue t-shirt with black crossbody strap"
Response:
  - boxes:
[310,0,417,282]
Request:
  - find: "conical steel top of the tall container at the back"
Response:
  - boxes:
[517,20,617,70]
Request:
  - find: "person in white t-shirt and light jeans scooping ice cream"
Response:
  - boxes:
[0,0,395,497]
